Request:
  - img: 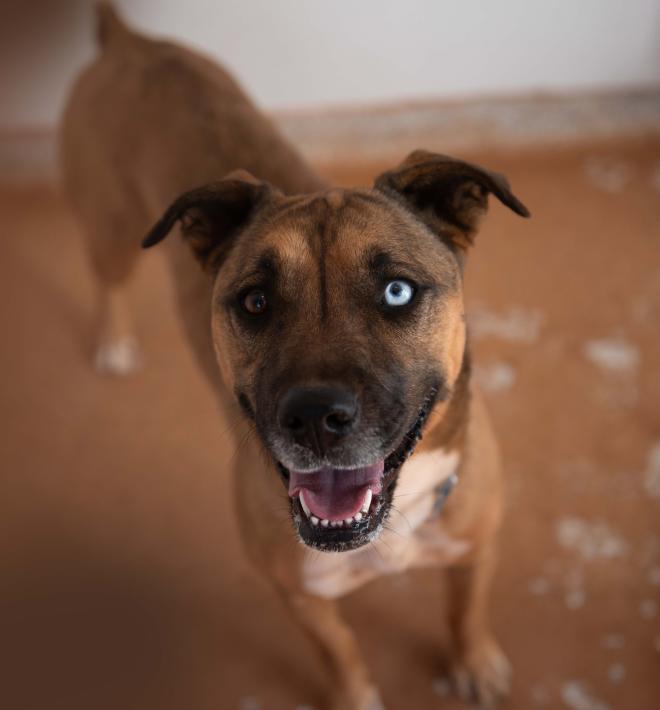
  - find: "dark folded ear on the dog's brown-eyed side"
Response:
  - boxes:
[142,170,274,270]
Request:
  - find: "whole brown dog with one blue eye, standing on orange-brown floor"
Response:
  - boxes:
[62,6,528,710]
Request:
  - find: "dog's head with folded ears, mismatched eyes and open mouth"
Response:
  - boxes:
[146,152,527,551]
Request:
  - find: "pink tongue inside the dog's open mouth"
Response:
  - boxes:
[289,461,385,520]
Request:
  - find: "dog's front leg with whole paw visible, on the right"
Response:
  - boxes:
[447,542,511,707]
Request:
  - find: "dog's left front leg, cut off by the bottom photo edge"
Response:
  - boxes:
[283,591,384,710]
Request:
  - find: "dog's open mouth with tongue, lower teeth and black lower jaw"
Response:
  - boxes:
[277,388,437,552]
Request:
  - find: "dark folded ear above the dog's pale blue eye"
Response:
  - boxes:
[374,150,530,248]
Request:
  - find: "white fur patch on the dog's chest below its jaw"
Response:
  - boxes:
[301,449,470,599]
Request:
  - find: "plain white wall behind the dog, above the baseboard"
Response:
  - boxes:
[0,0,660,128]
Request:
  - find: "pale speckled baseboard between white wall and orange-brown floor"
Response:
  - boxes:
[0,89,660,184]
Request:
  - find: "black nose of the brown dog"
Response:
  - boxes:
[278,385,358,453]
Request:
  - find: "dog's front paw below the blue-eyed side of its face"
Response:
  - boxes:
[449,638,512,708]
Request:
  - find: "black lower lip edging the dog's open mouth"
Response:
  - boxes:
[276,386,439,552]
